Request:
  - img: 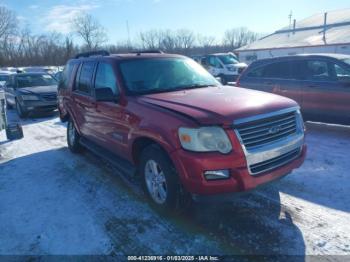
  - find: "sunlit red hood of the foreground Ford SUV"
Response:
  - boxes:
[138,86,298,125]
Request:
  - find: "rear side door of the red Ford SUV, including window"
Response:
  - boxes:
[72,61,96,141]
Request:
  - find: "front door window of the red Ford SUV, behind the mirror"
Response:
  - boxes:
[95,63,119,95]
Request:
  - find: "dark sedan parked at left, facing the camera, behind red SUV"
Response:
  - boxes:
[5,73,57,117]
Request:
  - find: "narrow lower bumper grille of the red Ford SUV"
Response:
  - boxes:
[250,148,301,175]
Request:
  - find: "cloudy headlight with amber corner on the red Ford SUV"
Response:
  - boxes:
[179,126,232,154]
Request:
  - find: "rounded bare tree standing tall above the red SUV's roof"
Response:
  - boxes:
[73,14,107,50]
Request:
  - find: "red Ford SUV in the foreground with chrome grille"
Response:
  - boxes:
[58,51,306,208]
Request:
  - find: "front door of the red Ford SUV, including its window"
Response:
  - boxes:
[94,62,129,156]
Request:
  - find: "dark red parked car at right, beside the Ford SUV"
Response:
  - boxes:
[237,54,350,124]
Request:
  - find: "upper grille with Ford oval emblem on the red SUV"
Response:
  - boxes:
[236,111,297,150]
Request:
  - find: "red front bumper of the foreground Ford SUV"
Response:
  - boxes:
[171,131,307,195]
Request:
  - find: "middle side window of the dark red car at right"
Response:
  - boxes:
[306,60,332,81]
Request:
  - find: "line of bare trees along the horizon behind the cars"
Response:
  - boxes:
[0,6,260,67]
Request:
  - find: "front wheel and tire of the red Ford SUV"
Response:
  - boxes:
[139,144,192,210]
